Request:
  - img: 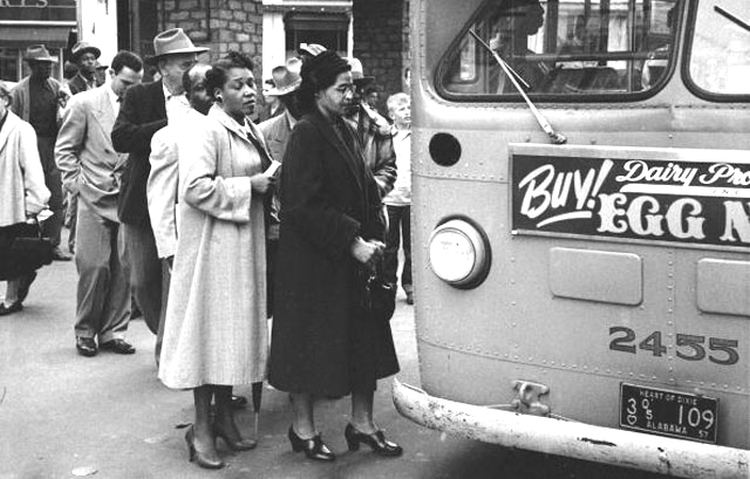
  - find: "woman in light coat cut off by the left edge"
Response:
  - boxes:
[0,81,50,316]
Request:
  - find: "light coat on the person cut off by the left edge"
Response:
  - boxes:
[0,111,50,227]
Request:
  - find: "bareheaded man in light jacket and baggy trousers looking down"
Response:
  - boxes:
[55,51,143,356]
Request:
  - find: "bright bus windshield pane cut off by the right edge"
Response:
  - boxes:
[688,0,750,95]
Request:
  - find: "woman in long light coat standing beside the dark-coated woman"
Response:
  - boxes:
[159,52,273,469]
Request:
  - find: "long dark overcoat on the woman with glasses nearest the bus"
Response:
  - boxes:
[269,112,399,396]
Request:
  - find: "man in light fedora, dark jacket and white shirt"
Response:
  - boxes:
[112,28,208,356]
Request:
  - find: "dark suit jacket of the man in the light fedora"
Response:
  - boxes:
[112,81,167,225]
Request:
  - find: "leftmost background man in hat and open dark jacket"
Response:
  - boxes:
[11,45,72,261]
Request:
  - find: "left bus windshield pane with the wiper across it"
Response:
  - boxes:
[438,0,680,101]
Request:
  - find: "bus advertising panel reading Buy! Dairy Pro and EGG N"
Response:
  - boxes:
[511,145,750,248]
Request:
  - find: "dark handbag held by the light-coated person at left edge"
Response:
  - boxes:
[0,222,53,281]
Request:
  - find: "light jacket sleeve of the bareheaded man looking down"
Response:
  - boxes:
[55,97,87,193]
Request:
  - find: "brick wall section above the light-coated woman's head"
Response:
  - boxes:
[158,0,263,66]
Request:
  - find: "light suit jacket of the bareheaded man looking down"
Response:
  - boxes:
[55,86,127,221]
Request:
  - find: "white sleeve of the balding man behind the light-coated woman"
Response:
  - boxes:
[146,127,179,258]
